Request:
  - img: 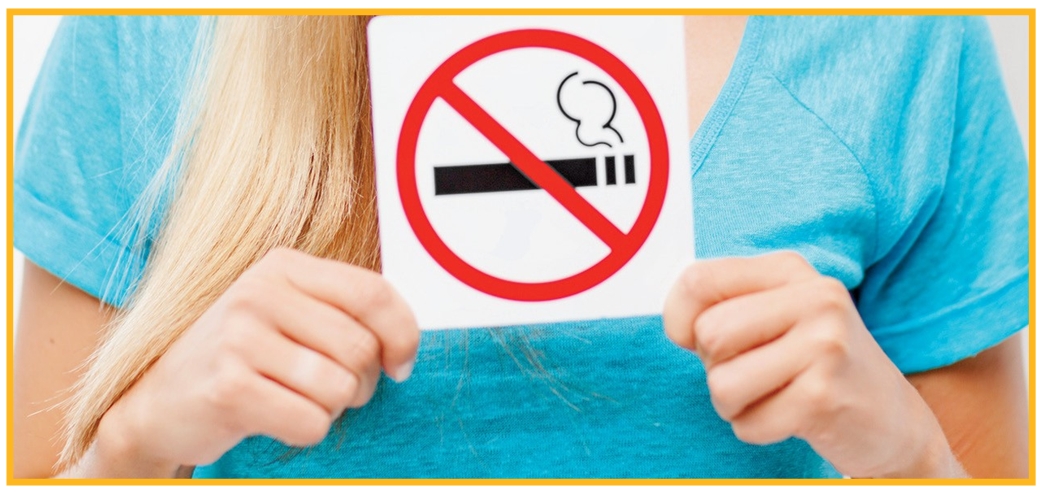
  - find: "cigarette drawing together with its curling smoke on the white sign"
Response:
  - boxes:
[435,72,635,195]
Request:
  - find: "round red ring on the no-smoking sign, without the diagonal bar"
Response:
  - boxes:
[396,29,668,301]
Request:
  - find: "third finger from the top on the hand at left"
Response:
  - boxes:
[246,330,361,415]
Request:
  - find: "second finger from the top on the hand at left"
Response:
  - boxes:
[264,286,381,382]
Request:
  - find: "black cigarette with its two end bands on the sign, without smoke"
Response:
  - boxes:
[435,155,635,195]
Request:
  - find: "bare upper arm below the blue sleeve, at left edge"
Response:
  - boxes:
[14,260,114,477]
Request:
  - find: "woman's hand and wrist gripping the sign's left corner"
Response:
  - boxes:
[86,249,419,477]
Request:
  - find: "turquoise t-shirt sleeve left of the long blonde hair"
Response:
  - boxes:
[14,17,137,303]
